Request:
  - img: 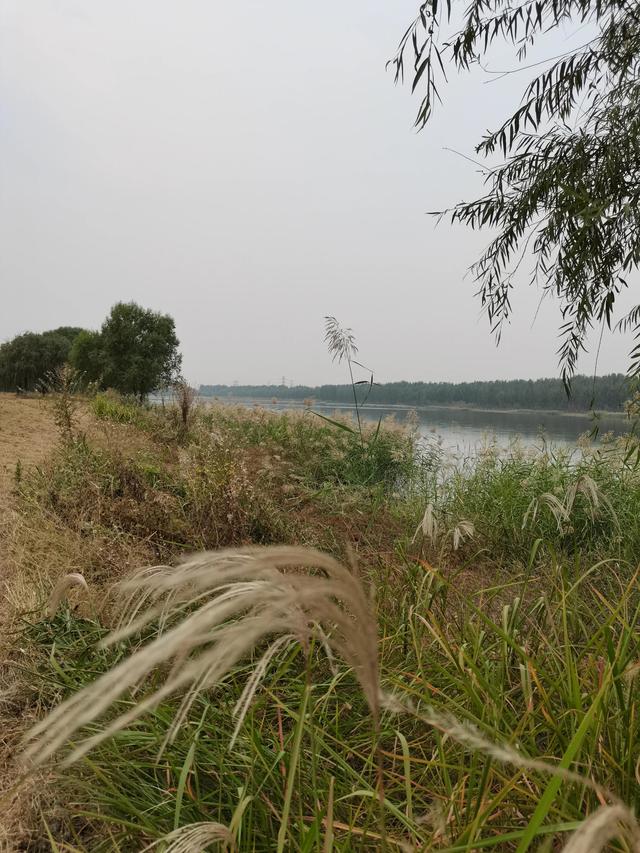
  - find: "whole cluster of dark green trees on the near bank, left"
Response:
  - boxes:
[0,302,181,399]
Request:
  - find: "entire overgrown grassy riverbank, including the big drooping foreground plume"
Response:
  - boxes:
[3,395,640,853]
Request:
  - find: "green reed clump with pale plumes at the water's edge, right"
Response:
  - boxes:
[420,444,640,561]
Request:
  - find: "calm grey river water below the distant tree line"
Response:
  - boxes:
[208,398,630,453]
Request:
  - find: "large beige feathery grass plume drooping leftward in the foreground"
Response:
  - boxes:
[25,546,379,765]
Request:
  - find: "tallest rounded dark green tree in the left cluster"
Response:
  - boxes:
[99,302,181,399]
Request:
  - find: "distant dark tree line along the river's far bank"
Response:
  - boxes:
[200,373,631,411]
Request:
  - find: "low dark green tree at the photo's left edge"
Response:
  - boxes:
[0,330,78,391]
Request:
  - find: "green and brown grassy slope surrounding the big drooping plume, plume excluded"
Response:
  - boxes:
[1,398,640,851]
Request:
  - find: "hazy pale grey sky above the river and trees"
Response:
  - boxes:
[0,0,628,384]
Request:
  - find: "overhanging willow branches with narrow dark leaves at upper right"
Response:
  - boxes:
[393,0,640,384]
